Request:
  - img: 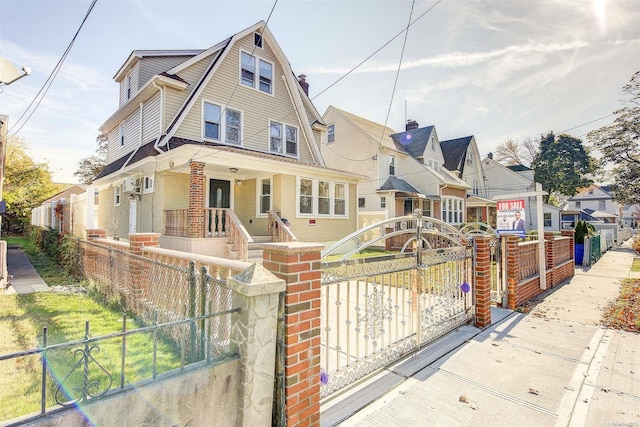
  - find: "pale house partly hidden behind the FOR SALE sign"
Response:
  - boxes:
[482,153,561,231]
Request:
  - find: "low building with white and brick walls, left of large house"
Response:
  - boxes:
[31,185,87,233]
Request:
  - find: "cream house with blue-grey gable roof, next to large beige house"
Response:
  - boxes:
[321,106,471,227]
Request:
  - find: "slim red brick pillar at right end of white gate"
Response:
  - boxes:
[473,236,492,328]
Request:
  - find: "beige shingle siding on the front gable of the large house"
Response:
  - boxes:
[176,34,313,162]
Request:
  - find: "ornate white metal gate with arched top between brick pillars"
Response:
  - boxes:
[321,211,474,397]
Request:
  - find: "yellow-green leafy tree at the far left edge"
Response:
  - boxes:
[2,136,63,233]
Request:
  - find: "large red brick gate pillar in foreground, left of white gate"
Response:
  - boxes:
[262,242,324,426]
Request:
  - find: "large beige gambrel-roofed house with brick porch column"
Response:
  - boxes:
[94,22,362,256]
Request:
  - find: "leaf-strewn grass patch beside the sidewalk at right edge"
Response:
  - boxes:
[602,279,640,332]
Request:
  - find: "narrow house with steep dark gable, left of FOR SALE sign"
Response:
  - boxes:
[440,135,496,226]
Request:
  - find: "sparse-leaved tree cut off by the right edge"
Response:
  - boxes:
[587,71,640,205]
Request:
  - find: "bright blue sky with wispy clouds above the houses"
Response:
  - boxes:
[0,0,640,183]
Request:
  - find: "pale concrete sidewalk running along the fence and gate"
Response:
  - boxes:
[321,239,640,426]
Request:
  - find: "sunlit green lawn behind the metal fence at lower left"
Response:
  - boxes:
[0,239,180,423]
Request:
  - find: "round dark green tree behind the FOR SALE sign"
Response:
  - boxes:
[531,132,596,202]
